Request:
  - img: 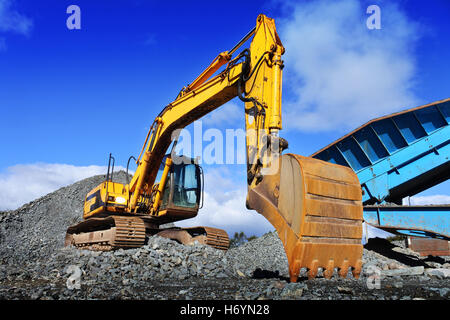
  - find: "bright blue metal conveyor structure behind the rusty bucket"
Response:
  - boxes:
[312,99,450,240]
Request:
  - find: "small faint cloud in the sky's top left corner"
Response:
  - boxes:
[0,0,33,36]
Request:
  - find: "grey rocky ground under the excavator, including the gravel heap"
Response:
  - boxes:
[0,173,450,300]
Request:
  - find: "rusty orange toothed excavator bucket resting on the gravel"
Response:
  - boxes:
[247,154,363,282]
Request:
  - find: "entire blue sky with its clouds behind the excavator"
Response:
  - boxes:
[0,0,450,233]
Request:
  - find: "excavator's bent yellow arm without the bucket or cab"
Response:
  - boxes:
[129,15,287,211]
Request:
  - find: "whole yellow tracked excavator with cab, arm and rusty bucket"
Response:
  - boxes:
[65,14,363,282]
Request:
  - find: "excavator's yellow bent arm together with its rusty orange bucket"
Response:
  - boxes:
[68,14,362,281]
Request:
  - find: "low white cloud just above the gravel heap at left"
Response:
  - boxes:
[0,163,121,210]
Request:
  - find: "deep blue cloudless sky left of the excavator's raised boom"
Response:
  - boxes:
[0,1,278,167]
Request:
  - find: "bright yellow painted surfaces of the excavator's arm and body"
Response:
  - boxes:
[84,14,284,217]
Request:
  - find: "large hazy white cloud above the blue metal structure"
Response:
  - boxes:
[277,0,420,132]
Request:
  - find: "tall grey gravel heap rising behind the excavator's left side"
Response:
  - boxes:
[0,171,126,264]
